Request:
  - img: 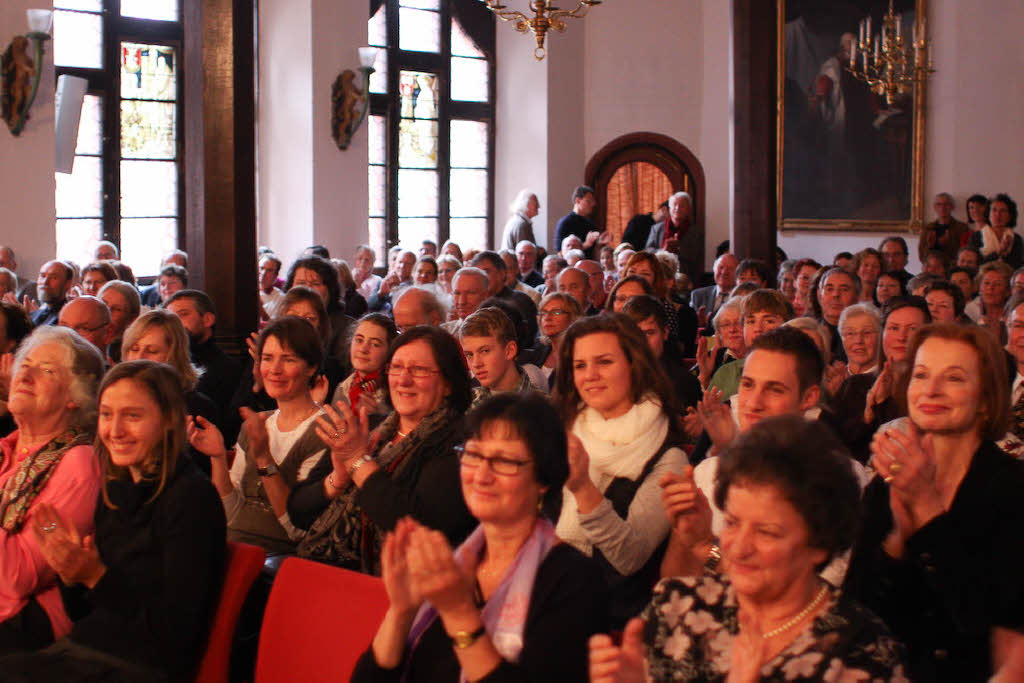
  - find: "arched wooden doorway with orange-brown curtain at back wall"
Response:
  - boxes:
[586,133,705,270]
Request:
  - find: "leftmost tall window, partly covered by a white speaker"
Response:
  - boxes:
[53,0,184,275]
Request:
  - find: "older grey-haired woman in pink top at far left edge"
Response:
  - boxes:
[0,327,103,653]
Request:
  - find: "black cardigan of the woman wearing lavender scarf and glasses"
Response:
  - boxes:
[351,544,606,683]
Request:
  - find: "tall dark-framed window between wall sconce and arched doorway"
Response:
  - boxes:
[368,0,495,265]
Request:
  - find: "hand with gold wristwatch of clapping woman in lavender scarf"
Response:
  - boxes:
[406,520,477,618]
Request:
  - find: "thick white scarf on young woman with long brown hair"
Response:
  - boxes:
[555,395,669,555]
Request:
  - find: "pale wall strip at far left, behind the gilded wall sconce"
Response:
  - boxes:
[0,0,56,280]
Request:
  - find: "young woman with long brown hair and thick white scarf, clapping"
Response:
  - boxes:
[555,313,686,628]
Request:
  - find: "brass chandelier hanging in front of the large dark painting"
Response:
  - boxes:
[847,0,935,106]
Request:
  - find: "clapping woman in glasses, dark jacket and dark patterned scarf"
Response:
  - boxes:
[288,326,473,574]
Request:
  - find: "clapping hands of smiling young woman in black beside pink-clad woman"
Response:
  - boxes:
[32,503,106,588]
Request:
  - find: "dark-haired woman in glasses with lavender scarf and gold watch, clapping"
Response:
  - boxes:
[352,393,605,683]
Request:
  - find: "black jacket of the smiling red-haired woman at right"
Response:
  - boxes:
[844,441,1024,682]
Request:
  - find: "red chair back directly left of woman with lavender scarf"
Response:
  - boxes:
[256,557,388,683]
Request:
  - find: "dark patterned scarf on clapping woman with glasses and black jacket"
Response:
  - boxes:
[298,404,459,575]
